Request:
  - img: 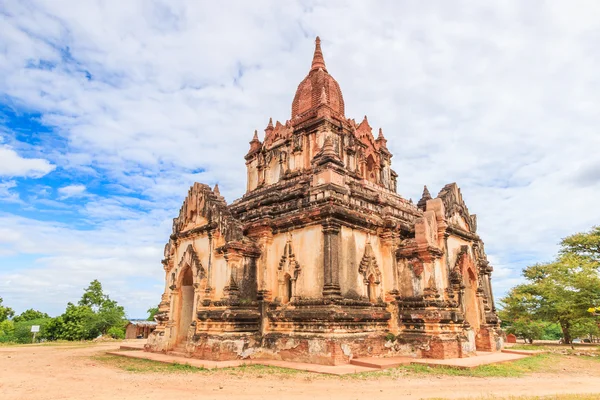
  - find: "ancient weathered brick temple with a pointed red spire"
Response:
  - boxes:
[146,38,502,364]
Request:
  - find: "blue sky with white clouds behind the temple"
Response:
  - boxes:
[0,0,600,317]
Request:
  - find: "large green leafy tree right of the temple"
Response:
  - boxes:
[501,228,600,343]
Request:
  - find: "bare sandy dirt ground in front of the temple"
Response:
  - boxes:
[0,343,600,400]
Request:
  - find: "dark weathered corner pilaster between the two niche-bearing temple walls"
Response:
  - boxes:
[322,221,342,298]
